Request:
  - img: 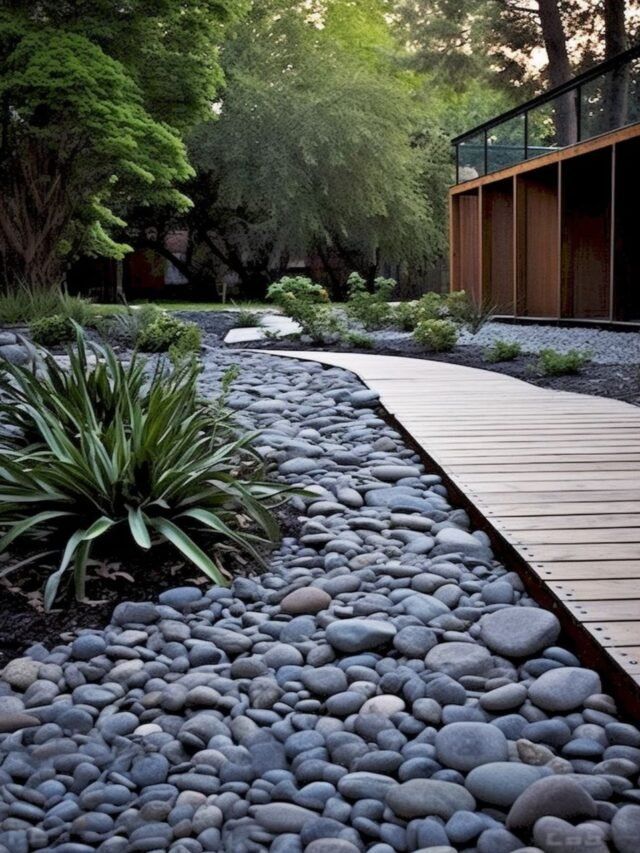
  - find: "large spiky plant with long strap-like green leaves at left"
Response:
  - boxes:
[0,327,288,609]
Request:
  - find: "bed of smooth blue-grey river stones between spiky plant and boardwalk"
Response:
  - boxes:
[0,350,640,853]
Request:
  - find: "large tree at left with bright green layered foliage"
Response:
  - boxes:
[0,0,242,286]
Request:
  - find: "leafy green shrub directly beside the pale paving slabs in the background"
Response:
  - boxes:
[267,276,344,343]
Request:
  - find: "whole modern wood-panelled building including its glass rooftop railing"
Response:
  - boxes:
[450,46,640,323]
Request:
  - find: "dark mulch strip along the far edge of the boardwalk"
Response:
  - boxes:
[239,338,640,406]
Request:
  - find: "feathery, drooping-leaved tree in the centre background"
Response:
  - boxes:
[160,0,450,294]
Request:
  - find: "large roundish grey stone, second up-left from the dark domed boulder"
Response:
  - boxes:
[435,723,509,772]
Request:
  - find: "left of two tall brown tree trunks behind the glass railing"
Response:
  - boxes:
[538,0,578,146]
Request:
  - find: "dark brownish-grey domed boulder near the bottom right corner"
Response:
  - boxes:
[507,776,597,831]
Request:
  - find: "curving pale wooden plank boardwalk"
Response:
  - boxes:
[268,352,640,685]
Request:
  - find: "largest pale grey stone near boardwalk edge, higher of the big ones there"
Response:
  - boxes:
[480,607,560,658]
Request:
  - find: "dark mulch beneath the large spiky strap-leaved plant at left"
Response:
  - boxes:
[0,505,300,669]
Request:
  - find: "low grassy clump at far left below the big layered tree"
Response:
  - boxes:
[0,284,93,326]
